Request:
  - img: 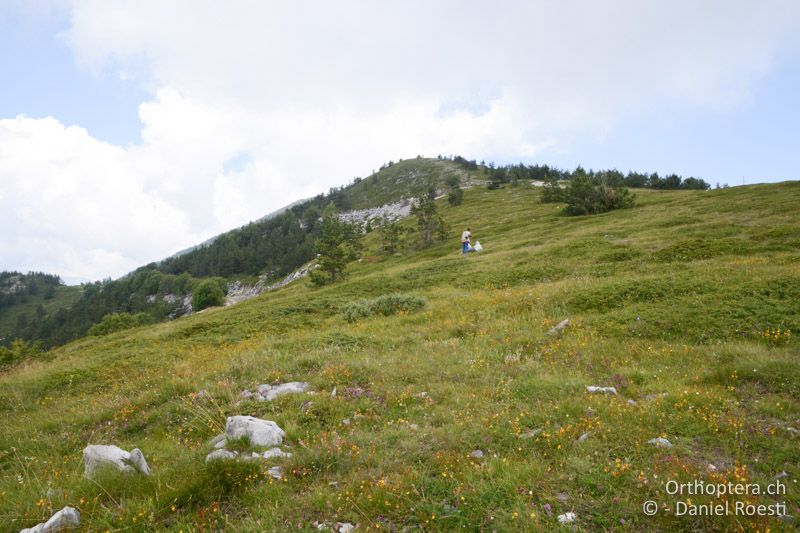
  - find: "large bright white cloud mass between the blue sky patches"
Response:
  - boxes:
[0,0,800,278]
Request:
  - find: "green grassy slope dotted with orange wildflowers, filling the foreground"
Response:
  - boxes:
[0,182,800,531]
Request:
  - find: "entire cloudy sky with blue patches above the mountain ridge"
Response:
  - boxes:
[0,0,800,283]
